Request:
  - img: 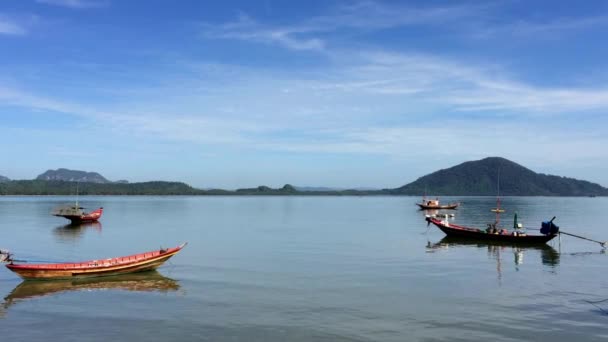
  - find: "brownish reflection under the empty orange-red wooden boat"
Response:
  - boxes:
[3,271,180,309]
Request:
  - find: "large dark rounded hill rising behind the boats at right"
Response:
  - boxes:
[390,157,608,196]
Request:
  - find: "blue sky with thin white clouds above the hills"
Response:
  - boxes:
[0,0,608,189]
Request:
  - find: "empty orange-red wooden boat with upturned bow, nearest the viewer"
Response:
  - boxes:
[6,243,186,279]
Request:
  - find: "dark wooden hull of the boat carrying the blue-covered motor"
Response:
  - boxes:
[426,217,557,245]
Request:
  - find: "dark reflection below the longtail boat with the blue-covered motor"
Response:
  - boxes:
[426,236,560,281]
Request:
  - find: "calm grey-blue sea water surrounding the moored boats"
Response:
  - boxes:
[0,197,608,341]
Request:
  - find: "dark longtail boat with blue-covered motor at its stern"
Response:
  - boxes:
[426,217,559,245]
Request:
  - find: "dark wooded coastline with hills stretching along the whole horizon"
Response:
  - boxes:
[0,157,608,196]
